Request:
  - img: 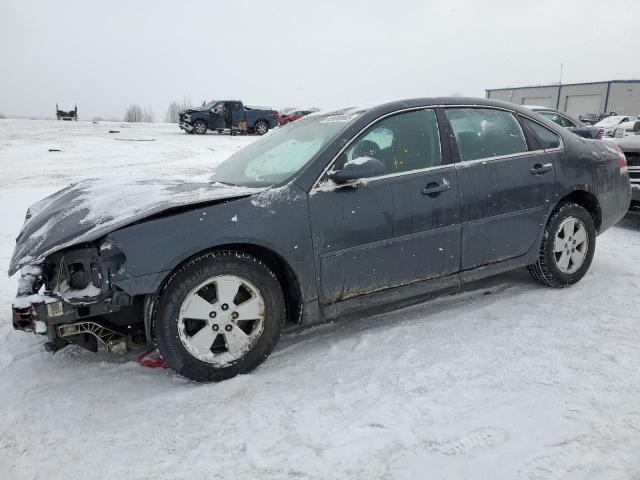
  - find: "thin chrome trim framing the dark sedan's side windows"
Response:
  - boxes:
[309,104,564,194]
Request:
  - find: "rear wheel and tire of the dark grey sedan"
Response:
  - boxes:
[527,203,596,288]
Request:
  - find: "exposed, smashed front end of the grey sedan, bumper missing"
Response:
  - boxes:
[12,243,145,354]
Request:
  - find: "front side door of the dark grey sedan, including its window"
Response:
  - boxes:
[309,109,460,305]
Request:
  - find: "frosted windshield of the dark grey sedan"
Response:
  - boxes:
[212,114,357,187]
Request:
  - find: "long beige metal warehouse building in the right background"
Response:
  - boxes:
[486,80,640,117]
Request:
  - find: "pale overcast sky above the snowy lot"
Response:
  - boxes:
[0,0,640,120]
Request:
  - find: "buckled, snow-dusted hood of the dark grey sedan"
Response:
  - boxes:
[9,180,266,275]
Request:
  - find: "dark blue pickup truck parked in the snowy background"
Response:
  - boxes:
[178,100,278,135]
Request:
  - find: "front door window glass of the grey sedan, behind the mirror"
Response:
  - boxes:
[336,109,442,174]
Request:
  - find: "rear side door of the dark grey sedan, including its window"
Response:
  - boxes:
[445,107,555,270]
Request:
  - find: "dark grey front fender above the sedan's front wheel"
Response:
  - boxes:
[103,185,317,300]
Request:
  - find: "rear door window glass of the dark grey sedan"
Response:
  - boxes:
[446,108,527,161]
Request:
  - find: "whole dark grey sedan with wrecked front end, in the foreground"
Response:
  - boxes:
[9,98,631,381]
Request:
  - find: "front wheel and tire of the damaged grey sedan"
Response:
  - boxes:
[151,251,286,382]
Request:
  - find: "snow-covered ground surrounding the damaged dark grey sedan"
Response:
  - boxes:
[0,120,640,480]
